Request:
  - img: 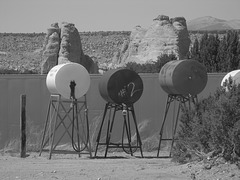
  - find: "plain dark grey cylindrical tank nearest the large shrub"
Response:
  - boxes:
[159,60,208,95]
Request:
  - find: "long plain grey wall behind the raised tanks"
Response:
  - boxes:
[0,74,225,148]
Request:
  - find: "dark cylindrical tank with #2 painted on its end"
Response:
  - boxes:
[99,69,143,105]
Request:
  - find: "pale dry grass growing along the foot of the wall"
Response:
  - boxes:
[0,113,170,154]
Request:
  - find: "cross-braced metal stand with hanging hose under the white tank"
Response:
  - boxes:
[39,94,92,159]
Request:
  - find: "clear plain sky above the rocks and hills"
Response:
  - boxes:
[0,0,240,33]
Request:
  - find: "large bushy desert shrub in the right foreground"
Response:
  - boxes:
[173,81,240,163]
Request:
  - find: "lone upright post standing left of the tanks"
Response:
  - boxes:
[20,94,26,158]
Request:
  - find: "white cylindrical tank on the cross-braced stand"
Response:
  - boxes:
[46,63,90,99]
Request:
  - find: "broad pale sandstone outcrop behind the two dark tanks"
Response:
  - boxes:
[114,15,191,64]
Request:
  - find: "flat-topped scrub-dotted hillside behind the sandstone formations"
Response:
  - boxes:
[0,31,234,74]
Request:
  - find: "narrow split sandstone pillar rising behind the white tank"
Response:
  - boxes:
[41,22,98,74]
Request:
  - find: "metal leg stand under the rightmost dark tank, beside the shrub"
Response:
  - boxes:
[157,94,198,157]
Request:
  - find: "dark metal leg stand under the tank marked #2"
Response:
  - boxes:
[95,102,143,158]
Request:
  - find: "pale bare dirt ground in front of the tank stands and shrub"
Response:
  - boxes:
[0,152,240,180]
